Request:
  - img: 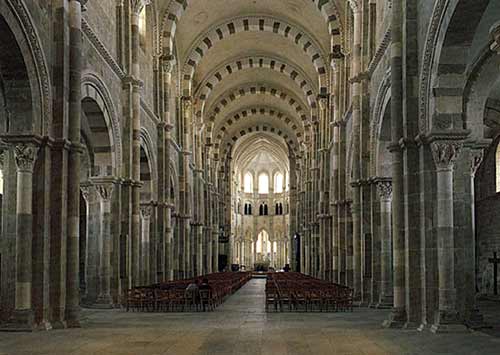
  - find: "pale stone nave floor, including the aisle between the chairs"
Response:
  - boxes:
[0,279,500,355]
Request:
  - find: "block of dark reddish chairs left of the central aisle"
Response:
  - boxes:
[122,272,251,312]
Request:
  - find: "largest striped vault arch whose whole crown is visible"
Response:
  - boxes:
[183,16,328,93]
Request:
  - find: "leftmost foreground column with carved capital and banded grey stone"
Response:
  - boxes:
[6,143,38,330]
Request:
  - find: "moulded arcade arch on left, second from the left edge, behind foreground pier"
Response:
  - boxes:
[82,73,122,173]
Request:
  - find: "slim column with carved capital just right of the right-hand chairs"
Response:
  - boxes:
[376,178,393,308]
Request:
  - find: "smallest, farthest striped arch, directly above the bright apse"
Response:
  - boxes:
[214,123,300,159]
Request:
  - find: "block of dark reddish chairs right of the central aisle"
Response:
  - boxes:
[266,272,353,312]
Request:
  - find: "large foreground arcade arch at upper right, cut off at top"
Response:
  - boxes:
[419,0,490,133]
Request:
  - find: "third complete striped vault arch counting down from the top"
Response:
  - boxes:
[206,84,317,130]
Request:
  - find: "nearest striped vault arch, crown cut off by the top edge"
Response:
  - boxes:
[162,0,342,55]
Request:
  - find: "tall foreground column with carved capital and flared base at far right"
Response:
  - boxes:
[431,139,466,333]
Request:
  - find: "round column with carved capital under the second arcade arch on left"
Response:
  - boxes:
[93,178,114,308]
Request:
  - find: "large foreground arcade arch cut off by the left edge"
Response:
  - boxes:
[0,0,52,135]
